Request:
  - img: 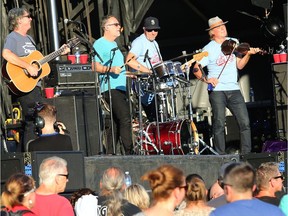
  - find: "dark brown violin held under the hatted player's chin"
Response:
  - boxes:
[221,39,267,58]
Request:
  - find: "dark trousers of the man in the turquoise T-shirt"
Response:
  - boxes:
[104,89,133,155]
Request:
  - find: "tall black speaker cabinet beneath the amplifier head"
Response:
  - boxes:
[48,94,101,156]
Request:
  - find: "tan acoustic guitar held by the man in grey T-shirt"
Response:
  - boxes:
[2,38,80,95]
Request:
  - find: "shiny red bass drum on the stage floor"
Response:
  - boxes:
[142,119,199,155]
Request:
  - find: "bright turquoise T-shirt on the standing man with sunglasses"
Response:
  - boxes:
[93,37,126,92]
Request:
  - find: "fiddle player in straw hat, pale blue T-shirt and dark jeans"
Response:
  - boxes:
[193,16,260,154]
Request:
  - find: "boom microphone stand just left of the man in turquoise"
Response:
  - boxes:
[76,31,104,155]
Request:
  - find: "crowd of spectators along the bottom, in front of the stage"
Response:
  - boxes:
[1,156,288,216]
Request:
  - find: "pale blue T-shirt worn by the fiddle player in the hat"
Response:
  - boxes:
[199,38,240,91]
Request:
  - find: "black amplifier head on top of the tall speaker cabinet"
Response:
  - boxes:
[45,64,96,89]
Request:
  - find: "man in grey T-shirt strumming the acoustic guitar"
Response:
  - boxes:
[2,8,70,151]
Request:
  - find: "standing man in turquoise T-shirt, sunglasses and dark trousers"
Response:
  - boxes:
[93,15,133,155]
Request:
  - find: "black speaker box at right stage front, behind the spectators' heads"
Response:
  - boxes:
[240,151,288,188]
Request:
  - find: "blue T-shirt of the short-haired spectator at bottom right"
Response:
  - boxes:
[210,199,285,216]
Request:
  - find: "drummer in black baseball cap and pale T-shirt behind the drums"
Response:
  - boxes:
[126,17,162,122]
